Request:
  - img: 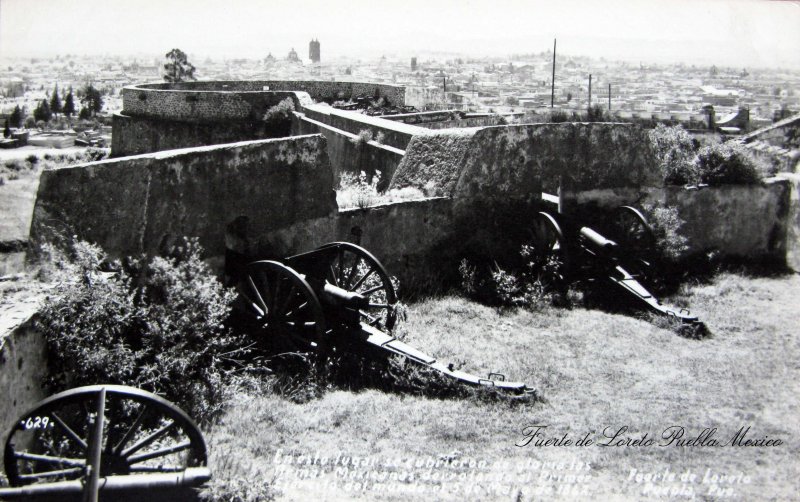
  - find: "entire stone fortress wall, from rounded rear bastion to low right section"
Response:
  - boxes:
[32,81,800,279]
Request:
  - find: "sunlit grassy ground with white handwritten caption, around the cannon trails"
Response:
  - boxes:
[209,274,800,500]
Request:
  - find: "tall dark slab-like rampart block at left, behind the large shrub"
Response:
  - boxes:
[31,135,337,266]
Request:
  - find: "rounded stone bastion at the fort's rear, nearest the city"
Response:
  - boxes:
[111,80,407,157]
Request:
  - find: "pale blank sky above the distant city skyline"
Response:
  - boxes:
[0,0,800,69]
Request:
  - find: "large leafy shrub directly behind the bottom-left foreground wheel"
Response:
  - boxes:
[38,241,244,423]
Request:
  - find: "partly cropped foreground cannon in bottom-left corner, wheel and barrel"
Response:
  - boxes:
[0,385,211,502]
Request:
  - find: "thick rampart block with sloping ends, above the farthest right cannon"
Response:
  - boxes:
[390,123,663,199]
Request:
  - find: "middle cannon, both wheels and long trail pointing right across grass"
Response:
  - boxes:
[237,242,535,397]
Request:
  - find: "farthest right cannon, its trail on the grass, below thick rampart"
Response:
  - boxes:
[531,198,704,332]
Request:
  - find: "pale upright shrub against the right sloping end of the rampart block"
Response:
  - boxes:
[647,124,700,185]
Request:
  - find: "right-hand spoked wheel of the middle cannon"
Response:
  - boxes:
[319,242,397,330]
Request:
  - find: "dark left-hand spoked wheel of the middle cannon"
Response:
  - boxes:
[237,261,326,349]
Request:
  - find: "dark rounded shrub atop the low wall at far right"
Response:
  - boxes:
[697,141,766,185]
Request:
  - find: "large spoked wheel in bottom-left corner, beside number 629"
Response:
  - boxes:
[3,385,206,486]
